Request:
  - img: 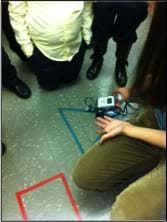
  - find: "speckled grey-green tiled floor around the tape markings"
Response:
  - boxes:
[2,18,150,221]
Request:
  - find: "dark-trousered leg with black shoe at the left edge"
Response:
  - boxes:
[2,48,31,99]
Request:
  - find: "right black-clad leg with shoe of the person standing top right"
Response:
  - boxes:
[113,2,147,86]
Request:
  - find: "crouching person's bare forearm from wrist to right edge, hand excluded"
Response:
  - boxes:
[123,125,166,148]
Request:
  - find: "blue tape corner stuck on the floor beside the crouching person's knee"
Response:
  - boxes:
[58,108,87,154]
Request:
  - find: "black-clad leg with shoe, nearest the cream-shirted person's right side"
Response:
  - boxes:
[87,2,116,80]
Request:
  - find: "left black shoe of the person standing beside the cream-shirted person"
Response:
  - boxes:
[86,60,103,80]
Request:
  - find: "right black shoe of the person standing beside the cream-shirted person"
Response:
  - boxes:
[115,59,128,87]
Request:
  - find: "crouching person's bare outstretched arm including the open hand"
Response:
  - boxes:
[96,116,166,148]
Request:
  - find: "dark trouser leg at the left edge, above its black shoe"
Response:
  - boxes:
[2,48,17,87]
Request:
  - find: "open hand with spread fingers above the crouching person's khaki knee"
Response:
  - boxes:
[96,116,132,144]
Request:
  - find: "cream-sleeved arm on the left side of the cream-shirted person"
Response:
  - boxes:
[9,1,34,57]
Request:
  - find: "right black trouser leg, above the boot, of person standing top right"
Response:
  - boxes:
[113,2,147,44]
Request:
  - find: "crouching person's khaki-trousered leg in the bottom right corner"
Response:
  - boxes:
[111,161,166,221]
